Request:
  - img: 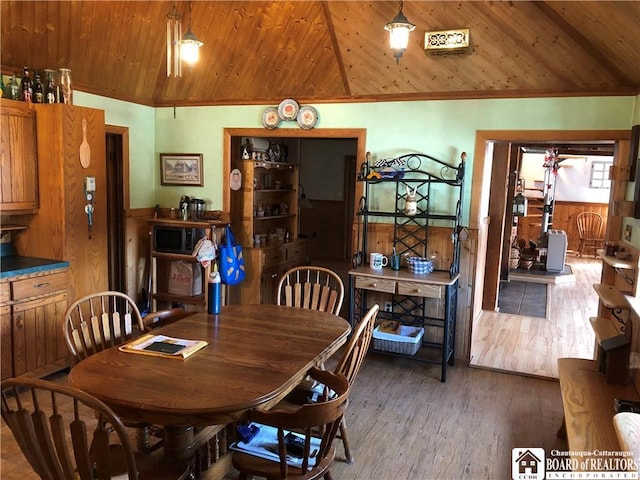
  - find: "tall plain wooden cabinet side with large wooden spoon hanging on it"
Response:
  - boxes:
[13,103,109,299]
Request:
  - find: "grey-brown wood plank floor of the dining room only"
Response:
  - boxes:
[0,353,567,480]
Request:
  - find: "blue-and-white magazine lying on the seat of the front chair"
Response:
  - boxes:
[230,422,321,469]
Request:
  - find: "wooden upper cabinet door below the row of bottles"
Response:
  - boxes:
[0,99,38,215]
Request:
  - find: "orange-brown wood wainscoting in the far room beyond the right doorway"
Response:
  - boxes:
[518,202,609,251]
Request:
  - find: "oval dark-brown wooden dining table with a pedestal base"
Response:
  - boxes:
[68,305,351,468]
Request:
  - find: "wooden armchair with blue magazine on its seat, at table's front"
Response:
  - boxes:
[232,367,349,480]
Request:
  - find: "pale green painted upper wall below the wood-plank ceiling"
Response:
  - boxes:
[74,92,640,231]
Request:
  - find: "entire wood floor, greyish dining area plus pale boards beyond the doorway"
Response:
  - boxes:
[0,257,600,480]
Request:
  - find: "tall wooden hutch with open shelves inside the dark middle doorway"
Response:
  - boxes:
[230,137,308,304]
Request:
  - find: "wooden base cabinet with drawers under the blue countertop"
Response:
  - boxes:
[0,269,69,379]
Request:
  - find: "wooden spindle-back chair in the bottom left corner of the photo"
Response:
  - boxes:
[0,377,189,480]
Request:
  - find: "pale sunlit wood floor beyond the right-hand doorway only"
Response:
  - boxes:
[470,256,602,378]
